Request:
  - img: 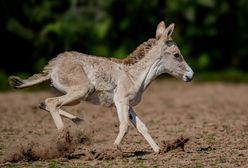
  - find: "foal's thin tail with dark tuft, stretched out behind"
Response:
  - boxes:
[9,73,50,89]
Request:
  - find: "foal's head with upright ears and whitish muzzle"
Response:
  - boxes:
[156,22,194,82]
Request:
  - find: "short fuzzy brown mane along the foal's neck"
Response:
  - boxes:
[111,38,156,65]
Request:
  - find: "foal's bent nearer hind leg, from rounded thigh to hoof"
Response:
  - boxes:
[39,61,94,129]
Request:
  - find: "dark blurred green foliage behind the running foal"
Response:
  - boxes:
[0,0,248,89]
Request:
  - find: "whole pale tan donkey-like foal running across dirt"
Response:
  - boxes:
[9,22,193,152]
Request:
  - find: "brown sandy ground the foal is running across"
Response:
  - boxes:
[0,80,248,168]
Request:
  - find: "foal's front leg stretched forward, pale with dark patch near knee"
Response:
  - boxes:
[129,107,159,152]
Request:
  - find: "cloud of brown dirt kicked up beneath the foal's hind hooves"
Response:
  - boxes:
[4,126,91,162]
